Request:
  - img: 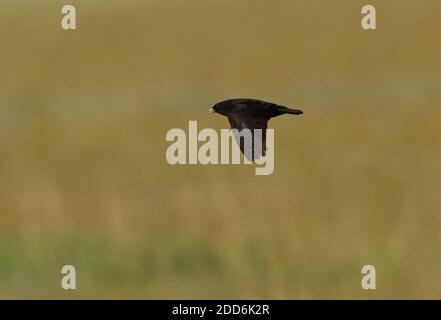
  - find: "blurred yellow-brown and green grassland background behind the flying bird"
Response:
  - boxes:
[0,0,441,299]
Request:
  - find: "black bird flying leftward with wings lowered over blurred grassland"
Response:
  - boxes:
[208,99,303,160]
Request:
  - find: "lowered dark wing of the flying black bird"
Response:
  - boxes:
[228,110,268,161]
